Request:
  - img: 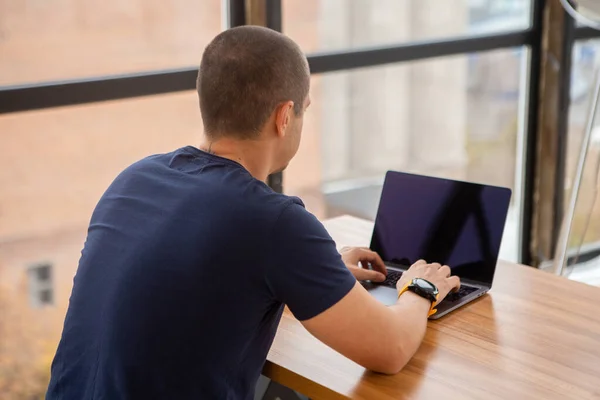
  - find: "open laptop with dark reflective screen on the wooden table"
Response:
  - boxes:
[364,171,511,319]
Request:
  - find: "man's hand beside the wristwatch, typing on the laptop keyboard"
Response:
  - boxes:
[396,260,460,303]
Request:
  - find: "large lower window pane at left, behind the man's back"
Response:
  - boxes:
[0,92,202,400]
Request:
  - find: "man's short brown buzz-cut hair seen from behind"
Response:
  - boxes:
[197,26,310,139]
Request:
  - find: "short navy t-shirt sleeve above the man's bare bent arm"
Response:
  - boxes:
[266,203,356,321]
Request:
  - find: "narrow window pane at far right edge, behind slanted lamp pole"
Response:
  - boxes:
[565,39,600,278]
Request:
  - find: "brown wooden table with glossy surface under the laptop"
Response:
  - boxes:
[263,216,600,400]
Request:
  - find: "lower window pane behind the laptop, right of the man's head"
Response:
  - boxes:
[284,49,527,260]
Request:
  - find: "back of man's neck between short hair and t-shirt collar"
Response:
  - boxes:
[200,138,270,182]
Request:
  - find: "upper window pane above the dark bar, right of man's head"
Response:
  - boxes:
[283,0,531,53]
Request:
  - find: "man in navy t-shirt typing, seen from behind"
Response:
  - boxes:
[47,27,459,399]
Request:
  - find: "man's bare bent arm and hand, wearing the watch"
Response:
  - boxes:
[302,262,460,374]
